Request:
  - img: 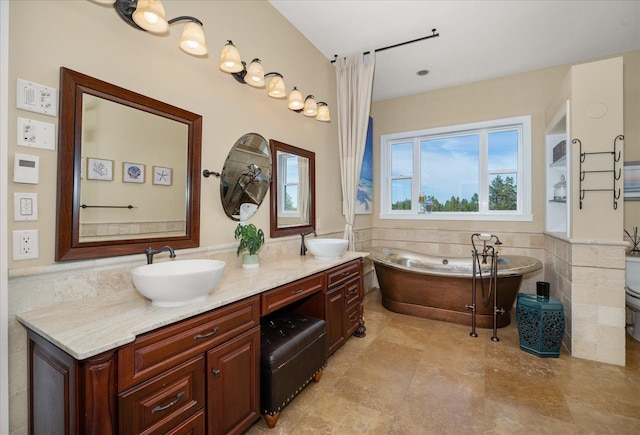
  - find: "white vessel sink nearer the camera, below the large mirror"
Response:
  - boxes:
[131,260,225,307]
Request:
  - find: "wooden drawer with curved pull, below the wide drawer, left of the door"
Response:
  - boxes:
[118,355,205,434]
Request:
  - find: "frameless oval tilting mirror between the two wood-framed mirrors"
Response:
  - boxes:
[220,133,271,221]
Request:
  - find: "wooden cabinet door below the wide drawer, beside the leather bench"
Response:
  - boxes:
[207,327,260,435]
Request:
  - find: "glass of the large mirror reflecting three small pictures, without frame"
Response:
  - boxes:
[79,94,189,243]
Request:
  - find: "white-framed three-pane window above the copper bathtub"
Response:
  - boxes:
[380,116,532,221]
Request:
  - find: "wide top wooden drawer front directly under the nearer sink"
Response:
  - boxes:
[118,296,260,391]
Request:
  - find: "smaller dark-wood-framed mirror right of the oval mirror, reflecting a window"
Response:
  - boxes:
[269,139,316,237]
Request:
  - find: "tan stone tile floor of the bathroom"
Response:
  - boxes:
[247,291,640,435]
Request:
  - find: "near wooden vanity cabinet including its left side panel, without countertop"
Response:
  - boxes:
[28,296,260,435]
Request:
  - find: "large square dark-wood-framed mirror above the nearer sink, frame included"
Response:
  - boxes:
[55,67,202,261]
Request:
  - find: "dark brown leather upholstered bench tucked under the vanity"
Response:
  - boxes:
[260,313,327,428]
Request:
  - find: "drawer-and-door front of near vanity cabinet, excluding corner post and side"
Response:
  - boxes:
[118,296,260,435]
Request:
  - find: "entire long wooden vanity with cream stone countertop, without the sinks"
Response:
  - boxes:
[17,252,366,434]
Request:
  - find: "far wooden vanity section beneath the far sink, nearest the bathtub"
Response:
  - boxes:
[324,259,364,355]
